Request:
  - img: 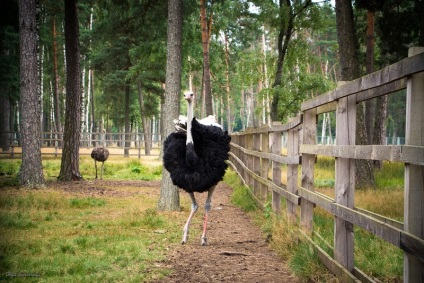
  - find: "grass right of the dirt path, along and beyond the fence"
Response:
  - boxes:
[224,157,404,282]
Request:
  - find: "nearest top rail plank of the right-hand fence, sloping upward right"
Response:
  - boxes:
[301,53,424,111]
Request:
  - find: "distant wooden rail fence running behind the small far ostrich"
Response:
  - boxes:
[0,132,161,158]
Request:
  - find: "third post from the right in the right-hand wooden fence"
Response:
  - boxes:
[300,108,317,232]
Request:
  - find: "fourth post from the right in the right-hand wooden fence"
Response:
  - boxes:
[287,121,299,218]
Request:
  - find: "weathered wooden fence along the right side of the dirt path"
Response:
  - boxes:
[229,47,424,282]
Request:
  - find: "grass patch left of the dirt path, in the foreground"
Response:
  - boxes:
[0,185,183,282]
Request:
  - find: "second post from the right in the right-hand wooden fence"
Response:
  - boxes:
[334,87,356,272]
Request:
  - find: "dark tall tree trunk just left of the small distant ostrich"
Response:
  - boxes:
[58,0,82,181]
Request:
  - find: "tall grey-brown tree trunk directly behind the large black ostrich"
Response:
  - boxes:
[158,0,183,210]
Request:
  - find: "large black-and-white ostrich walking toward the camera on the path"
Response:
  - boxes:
[163,91,231,246]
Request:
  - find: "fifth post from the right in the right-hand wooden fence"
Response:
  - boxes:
[271,122,282,214]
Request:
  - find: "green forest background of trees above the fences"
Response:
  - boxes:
[0,0,424,187]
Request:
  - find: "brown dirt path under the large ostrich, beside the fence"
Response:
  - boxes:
[156,183,298,283]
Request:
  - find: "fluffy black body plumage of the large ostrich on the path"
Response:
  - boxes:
[163,118,231,192]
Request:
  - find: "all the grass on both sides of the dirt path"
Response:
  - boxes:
[0,156,404,282]
